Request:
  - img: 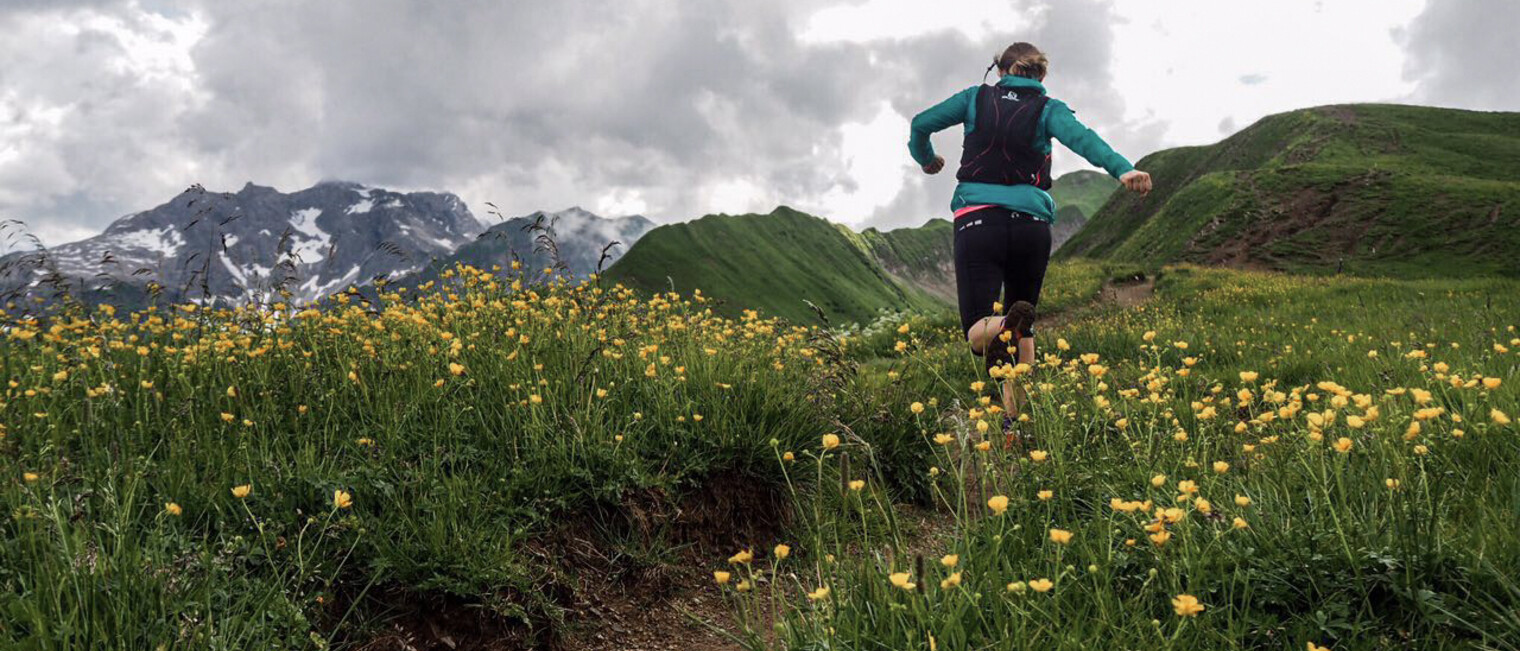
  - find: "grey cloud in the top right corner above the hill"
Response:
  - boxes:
[1403,0,1520,111]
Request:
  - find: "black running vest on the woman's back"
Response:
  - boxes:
[955,85,1050,190]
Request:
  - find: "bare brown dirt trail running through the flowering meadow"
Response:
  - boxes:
[561,277,1155,651]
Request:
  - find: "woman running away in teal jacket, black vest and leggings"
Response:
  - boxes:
[907,43,1151,415]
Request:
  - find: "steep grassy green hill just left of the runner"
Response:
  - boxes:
[606,207,955,322]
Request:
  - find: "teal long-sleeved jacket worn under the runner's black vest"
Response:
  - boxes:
[907,75,1135,224]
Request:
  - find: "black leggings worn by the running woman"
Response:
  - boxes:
[955,207,1050,336]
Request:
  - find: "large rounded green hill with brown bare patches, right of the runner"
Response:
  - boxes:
[1059,105,1520,277]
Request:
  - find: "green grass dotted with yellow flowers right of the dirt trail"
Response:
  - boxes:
[713,268,1520,649]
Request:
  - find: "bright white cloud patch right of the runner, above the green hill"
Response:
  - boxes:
[1114,0,1423,144]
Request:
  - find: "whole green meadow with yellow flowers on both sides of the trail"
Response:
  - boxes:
[0,260,1520,651]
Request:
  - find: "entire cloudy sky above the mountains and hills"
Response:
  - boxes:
[0,0,1520,243]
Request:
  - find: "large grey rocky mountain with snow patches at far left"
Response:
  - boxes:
[0,183,483,304]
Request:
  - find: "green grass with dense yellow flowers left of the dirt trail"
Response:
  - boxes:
[0,274,857,649]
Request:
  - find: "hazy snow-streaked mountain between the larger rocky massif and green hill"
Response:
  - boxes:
[409,207,655,283]
